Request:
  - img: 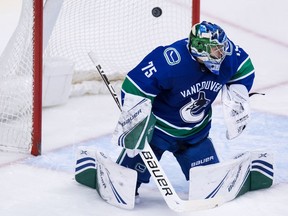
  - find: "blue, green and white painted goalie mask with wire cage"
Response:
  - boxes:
[188,21,229,75]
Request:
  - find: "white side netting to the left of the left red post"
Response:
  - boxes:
[0,0,33,152]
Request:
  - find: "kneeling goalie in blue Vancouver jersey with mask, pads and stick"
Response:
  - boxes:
[76,21,273,211]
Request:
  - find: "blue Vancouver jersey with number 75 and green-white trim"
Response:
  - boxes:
[121,39,254,139]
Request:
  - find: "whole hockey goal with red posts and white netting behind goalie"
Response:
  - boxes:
[0,0,199,155]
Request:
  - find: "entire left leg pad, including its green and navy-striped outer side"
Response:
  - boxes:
[75,147,137,209]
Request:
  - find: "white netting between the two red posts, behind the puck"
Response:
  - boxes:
[44,0,192,95]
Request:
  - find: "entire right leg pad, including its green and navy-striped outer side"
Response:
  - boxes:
[189,151,274,202]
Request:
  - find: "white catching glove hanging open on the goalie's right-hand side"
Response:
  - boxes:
[222,84,250,139]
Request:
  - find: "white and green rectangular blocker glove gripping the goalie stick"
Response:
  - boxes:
[112,93,156,150]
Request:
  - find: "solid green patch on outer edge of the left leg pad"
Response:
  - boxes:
[75,169,97,189]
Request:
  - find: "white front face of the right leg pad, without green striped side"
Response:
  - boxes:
[189,152,251,202]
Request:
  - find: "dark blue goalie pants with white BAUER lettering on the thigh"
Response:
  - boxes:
[117,129,219,187]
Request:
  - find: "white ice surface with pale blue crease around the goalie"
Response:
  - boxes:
[0,0,288,216]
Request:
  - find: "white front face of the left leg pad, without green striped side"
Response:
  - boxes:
[96,152,137,209]
